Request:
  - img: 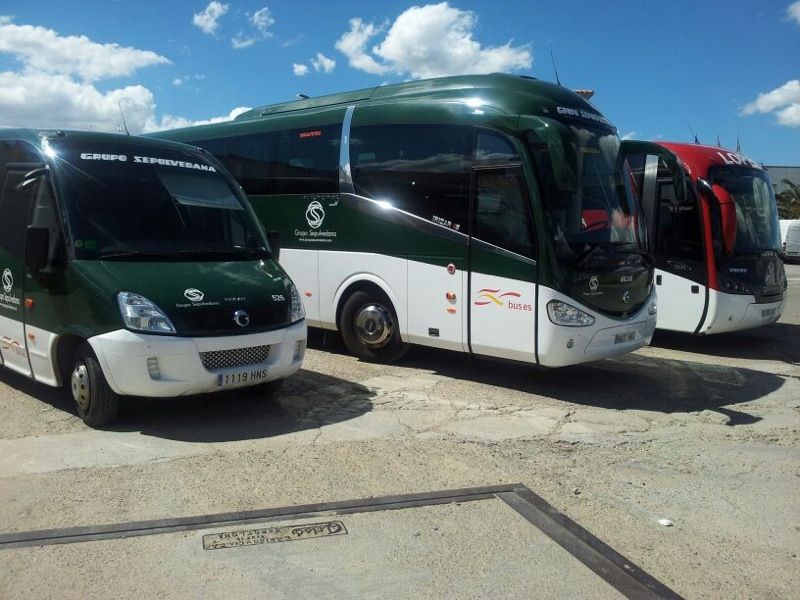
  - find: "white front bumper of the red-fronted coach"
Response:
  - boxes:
[699,290,786,334]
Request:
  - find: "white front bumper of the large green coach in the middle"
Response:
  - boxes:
[538,287,656,367]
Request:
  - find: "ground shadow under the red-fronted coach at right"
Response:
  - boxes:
[652,323,800,364]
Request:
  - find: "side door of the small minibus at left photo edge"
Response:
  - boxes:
[0,163,42,376]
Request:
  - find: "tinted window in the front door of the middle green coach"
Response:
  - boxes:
[473,168,534,256]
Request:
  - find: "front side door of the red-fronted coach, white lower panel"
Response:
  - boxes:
[627,148,708,332]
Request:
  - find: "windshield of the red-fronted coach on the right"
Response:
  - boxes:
[710,167,781,254]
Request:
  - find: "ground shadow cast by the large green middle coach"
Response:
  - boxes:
[311,334,784,425]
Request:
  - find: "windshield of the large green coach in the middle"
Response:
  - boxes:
[531,124,647,263]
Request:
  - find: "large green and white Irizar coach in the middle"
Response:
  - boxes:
[152,74,663,366]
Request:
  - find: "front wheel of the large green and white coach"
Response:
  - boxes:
[339,291,409,363]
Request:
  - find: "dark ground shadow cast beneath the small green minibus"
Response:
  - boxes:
[0,369,374,442]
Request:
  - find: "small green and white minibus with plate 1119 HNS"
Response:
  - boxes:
[0,129,306,426]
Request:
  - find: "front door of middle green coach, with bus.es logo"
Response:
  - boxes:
[468,166,536,362]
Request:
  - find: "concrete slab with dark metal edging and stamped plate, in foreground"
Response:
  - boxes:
[0,485,675,599]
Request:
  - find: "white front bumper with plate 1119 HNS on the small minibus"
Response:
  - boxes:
[88,321,307,398]
